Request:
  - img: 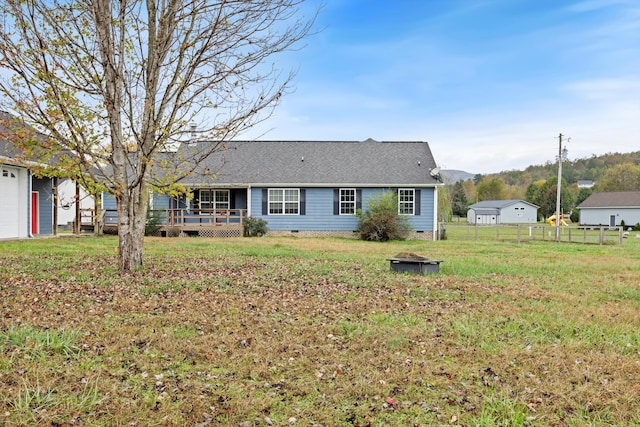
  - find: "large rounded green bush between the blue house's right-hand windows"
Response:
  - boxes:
[358,191,411,242]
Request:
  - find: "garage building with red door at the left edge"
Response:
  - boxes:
[0,113,54,239]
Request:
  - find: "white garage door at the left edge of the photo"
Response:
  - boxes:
[0,166,21,239]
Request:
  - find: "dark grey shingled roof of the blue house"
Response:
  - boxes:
[181,140,441,186]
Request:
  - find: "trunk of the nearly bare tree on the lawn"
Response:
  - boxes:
[118,186,148,272]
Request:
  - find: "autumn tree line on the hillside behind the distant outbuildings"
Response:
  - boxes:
[438,151,640,222]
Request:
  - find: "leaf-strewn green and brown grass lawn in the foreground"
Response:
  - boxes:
[0,237,640,427]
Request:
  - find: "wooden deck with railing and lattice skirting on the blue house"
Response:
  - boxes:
[103,209,246,237]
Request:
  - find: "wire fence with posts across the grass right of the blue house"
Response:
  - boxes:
[439,223,628,245]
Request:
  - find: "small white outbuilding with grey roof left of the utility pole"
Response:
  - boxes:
[467,200,538,225]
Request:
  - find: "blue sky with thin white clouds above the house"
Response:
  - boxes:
[248,0,640,173]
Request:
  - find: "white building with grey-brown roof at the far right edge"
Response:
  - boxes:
[578,191,640,227]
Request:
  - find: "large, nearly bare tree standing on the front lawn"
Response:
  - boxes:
[0,0,317,271]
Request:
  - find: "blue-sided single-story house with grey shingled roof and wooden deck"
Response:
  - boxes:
[102,139,442,240]
